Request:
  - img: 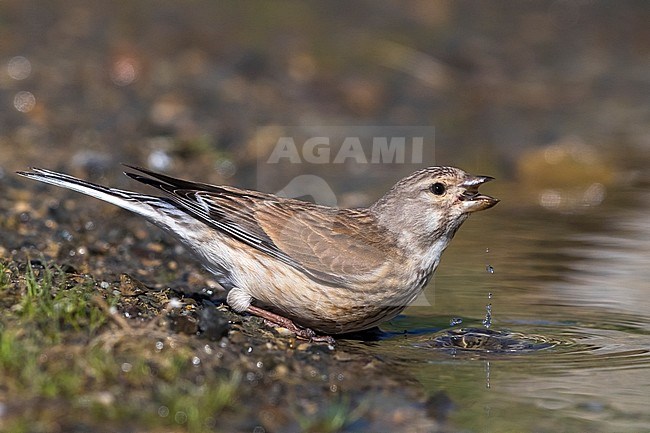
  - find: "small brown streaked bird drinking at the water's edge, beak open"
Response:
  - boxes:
[18,166,499,338]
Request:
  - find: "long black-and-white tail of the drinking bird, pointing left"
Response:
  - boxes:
[17,168,174,222]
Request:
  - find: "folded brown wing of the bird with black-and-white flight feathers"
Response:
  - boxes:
[127,167,396,287]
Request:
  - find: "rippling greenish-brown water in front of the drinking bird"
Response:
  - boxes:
[346,182,650,433]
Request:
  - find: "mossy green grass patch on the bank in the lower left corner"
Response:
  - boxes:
[0,261,241,432]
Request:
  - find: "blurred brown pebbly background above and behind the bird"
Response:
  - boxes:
[0,0,650,202]
